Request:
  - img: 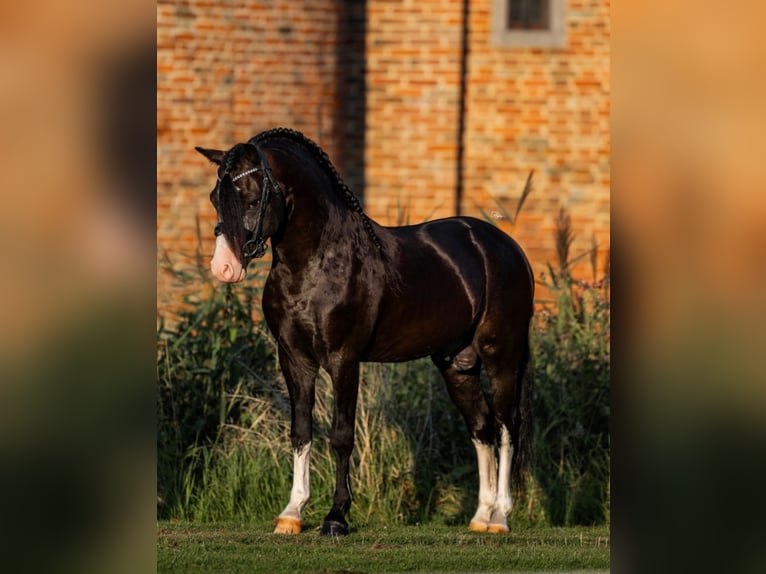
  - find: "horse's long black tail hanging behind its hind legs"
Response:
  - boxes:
[511,328,534,497]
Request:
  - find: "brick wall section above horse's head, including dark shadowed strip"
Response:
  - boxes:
[157,0,364,316]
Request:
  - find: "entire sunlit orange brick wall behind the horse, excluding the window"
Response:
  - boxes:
[157,0,610,316]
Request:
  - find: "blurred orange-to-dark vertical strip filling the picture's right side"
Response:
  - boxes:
[612,0,766,572]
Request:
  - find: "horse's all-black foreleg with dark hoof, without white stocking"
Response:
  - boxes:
[321,362,359,536]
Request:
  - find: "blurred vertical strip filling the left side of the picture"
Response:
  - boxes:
[0,0,156,572]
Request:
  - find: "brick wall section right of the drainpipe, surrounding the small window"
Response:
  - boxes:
[463,0,610,278]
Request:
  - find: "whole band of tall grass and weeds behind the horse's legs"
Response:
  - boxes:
[157,205,609,525]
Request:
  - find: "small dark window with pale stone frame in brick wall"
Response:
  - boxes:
[492,0,566,48]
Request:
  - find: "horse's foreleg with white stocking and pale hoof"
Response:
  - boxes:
[274,348,319,534]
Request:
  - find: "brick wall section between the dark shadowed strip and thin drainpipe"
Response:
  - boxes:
[365,0,462,224]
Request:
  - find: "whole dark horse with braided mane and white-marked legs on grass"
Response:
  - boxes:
[196,128,534,535]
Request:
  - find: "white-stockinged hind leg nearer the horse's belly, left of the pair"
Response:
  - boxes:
[432,356,498,532]
